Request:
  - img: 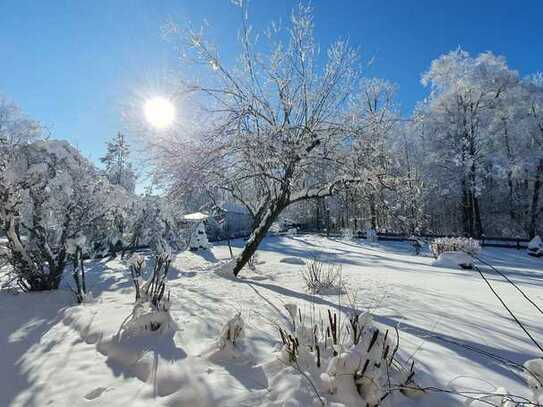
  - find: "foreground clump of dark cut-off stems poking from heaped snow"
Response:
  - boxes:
[278,304,423,406]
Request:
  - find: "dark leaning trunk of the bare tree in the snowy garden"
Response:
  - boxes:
[234,192,289,276]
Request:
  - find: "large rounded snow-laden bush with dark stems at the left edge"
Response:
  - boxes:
[0,140,110,291]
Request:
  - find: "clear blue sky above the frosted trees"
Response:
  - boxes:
[0,0,543,165]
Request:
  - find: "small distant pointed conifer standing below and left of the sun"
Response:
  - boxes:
[100,132,136,193]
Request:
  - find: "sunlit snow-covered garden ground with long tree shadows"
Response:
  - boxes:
[0,236,543,407]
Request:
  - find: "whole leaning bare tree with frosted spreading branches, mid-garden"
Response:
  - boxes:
[155,2,376,275]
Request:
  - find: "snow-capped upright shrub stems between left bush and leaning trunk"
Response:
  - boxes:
[122,253,173,335]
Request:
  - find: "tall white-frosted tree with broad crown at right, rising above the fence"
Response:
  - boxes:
[417,49,518,237]
